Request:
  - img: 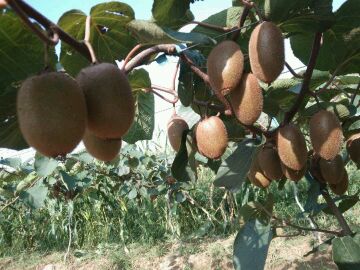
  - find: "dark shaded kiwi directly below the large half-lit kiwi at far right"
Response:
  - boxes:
[319,155,344,184]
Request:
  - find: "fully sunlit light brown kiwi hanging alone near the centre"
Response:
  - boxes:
[195,116,228,159]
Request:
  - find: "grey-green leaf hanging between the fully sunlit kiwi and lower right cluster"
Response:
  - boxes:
[214,139,258,192]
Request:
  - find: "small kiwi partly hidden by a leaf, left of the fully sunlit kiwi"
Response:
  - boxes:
[167,114,189,152]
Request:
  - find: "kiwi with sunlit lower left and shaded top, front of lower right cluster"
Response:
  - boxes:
[276,124,307,171]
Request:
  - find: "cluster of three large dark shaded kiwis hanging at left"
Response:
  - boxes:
[17,63,135,161]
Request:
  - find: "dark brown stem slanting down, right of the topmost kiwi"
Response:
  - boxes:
[282,32,322,125]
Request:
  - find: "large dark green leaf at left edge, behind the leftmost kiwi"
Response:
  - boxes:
[0,10,56,150]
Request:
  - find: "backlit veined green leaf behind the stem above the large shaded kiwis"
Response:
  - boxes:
[58,2,136,75]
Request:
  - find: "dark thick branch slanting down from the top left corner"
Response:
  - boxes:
[7,0,91,61]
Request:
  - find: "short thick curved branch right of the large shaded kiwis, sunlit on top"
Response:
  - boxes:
[124,44,177,73]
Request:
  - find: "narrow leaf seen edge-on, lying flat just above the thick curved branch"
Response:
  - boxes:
[128,20,216,45]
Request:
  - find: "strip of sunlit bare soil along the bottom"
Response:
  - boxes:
[0,235,337,270]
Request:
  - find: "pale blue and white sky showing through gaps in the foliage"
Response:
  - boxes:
[0,0,348,160]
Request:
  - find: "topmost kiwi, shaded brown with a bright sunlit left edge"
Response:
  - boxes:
[249,22,285,83]
